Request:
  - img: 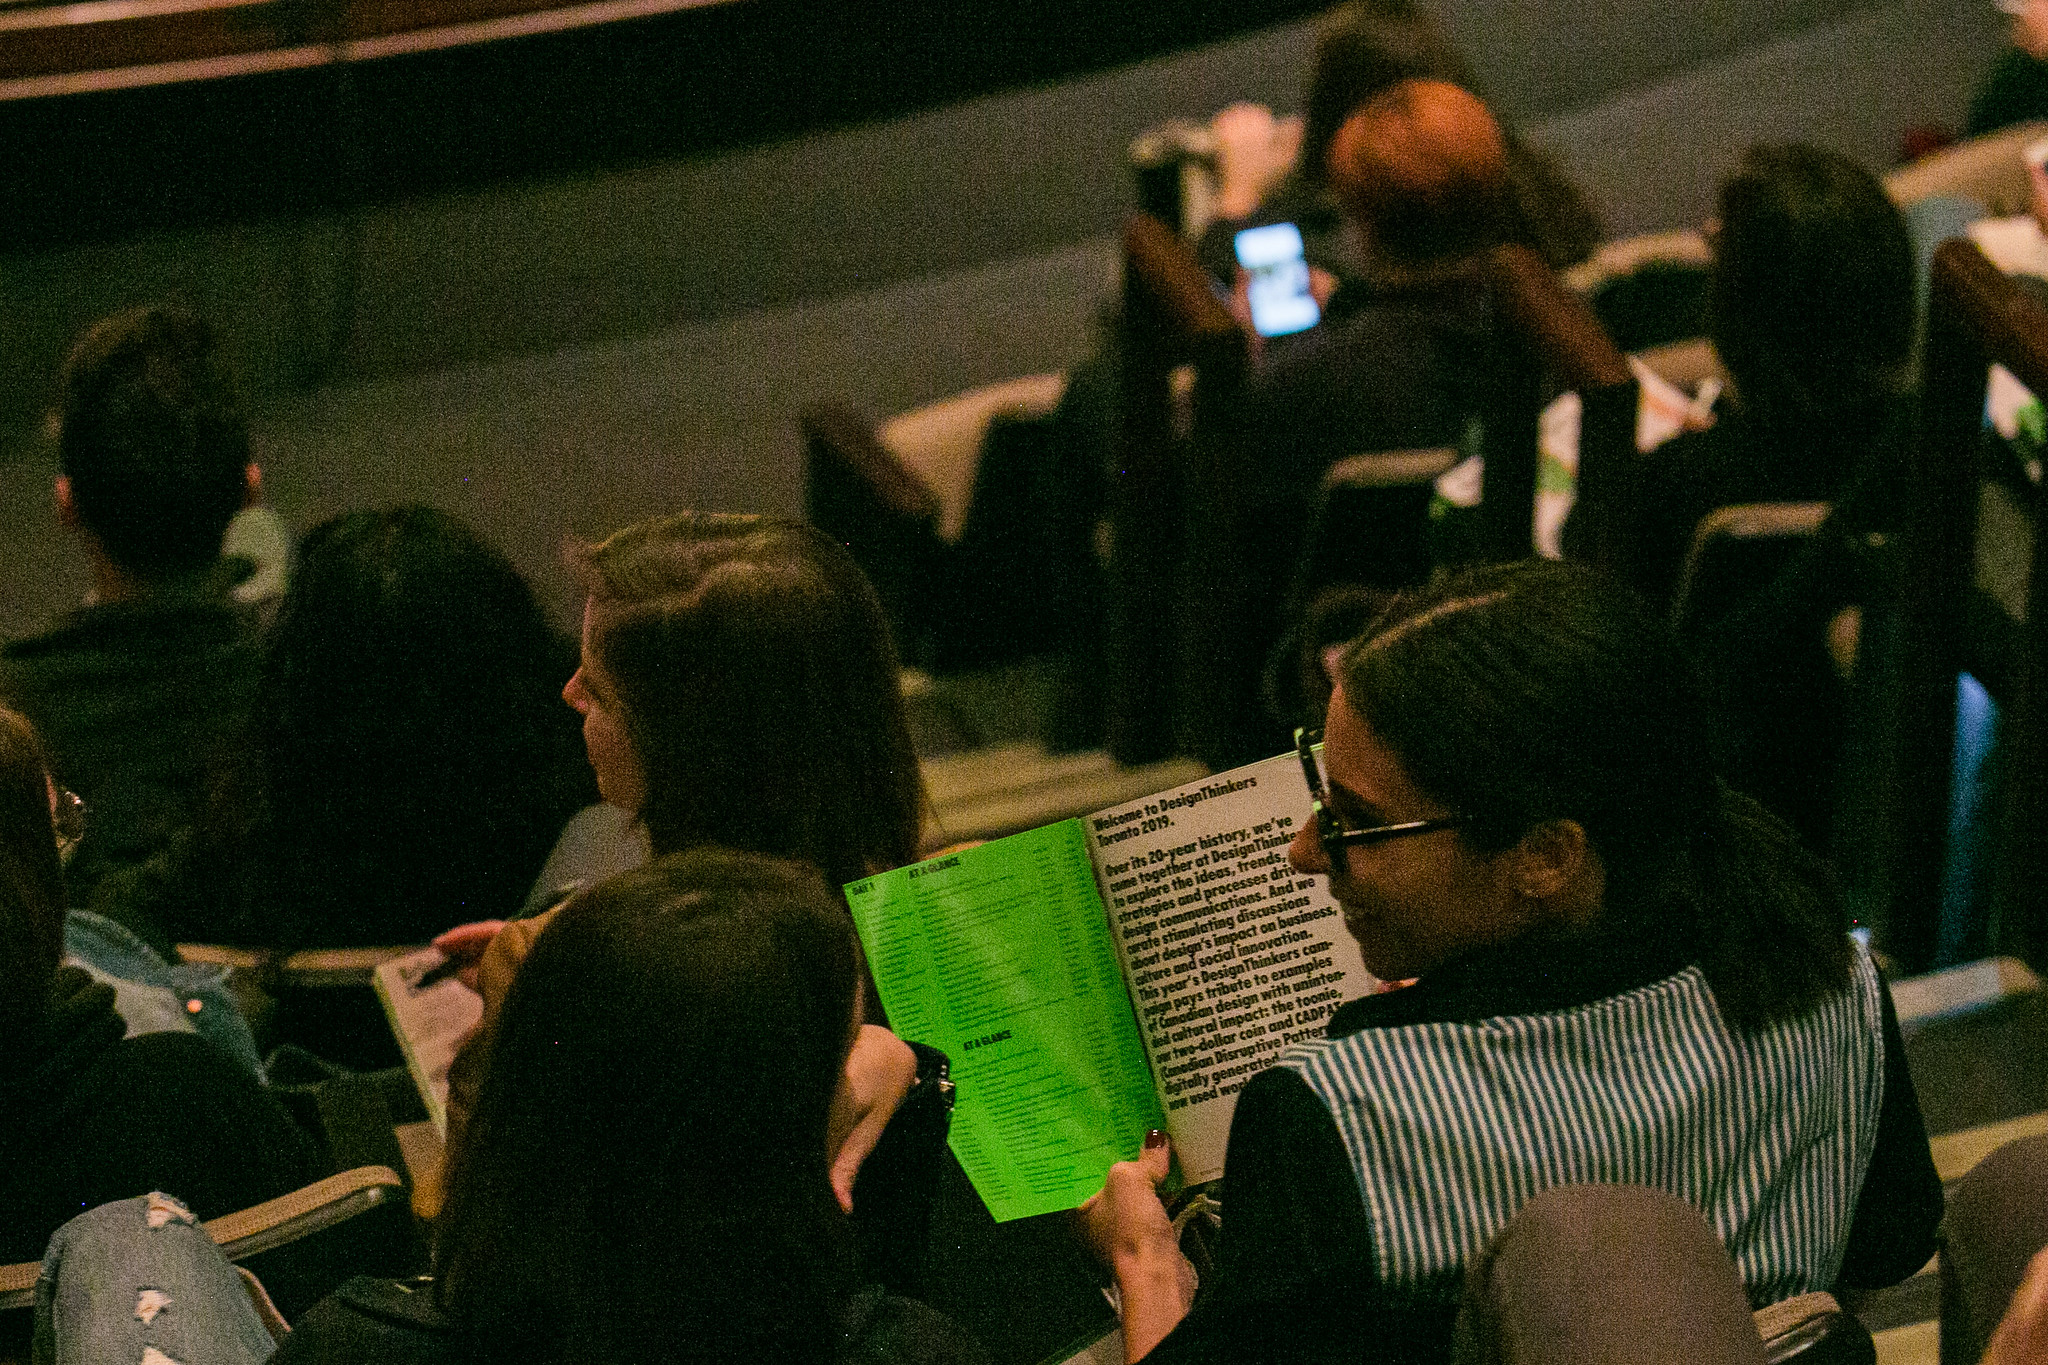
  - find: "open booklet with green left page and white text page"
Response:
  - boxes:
[846,753,1378,1222]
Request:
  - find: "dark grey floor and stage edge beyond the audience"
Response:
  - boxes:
[0,0,2001,634]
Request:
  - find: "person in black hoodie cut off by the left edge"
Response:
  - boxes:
[0,708,326,1263]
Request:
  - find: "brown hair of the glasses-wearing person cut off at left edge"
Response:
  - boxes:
[0,706,63,1038]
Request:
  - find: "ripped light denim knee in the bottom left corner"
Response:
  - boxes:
[33,1193,276,1365]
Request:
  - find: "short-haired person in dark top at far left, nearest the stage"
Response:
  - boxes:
[0,305,260,896]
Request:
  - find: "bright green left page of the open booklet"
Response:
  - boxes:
[846,821,1165,1222]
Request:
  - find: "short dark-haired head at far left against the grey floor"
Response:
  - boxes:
[57,305,250,579]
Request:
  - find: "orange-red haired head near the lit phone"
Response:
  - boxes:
[1329,80,1509,266]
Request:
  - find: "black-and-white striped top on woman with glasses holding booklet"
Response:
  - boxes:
[1280,950,1884,1306]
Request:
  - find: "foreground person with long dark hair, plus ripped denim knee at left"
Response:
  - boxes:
[37,847,987,1365]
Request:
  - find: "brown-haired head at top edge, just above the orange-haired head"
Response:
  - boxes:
[1300,0,1470,184]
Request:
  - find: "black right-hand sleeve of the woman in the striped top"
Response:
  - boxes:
[1837,988,1942,1289]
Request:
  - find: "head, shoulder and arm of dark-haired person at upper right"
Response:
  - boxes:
[1565,143,1915,606]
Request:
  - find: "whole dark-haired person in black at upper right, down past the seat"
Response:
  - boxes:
[1565,145,1917,849]
